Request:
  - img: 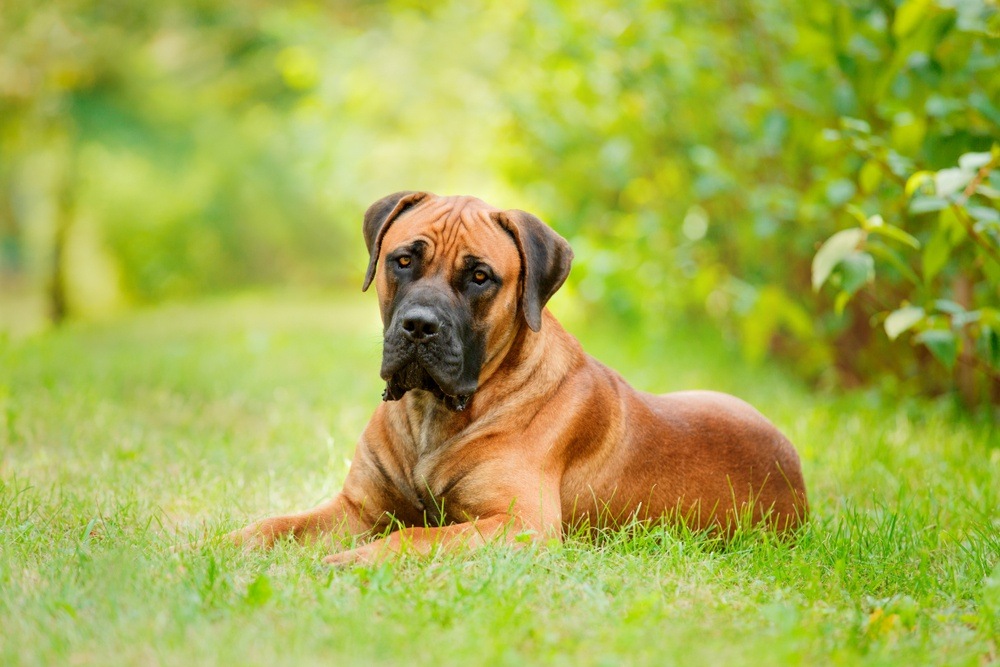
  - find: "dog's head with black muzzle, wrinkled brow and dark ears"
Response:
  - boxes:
[363,192,573,410]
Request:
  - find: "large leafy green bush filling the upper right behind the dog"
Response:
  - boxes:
[508,0,1000,408]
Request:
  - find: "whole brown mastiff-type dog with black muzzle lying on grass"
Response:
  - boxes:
[231,192,807,563]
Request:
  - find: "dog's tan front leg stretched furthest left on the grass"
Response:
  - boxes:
[226,492,373,548]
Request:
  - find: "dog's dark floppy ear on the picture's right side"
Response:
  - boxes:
[493,209,573,331]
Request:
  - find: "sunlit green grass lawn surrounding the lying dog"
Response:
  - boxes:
[0,297,1000,665]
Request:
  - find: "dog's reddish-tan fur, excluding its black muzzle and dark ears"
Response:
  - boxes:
[231,196,807,563]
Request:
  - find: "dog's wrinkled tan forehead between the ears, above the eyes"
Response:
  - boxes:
[382,197,520,268]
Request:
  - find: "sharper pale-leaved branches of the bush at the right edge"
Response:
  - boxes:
[812,136,1000,401]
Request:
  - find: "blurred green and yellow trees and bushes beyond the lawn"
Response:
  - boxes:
[0,0,1000,406]
